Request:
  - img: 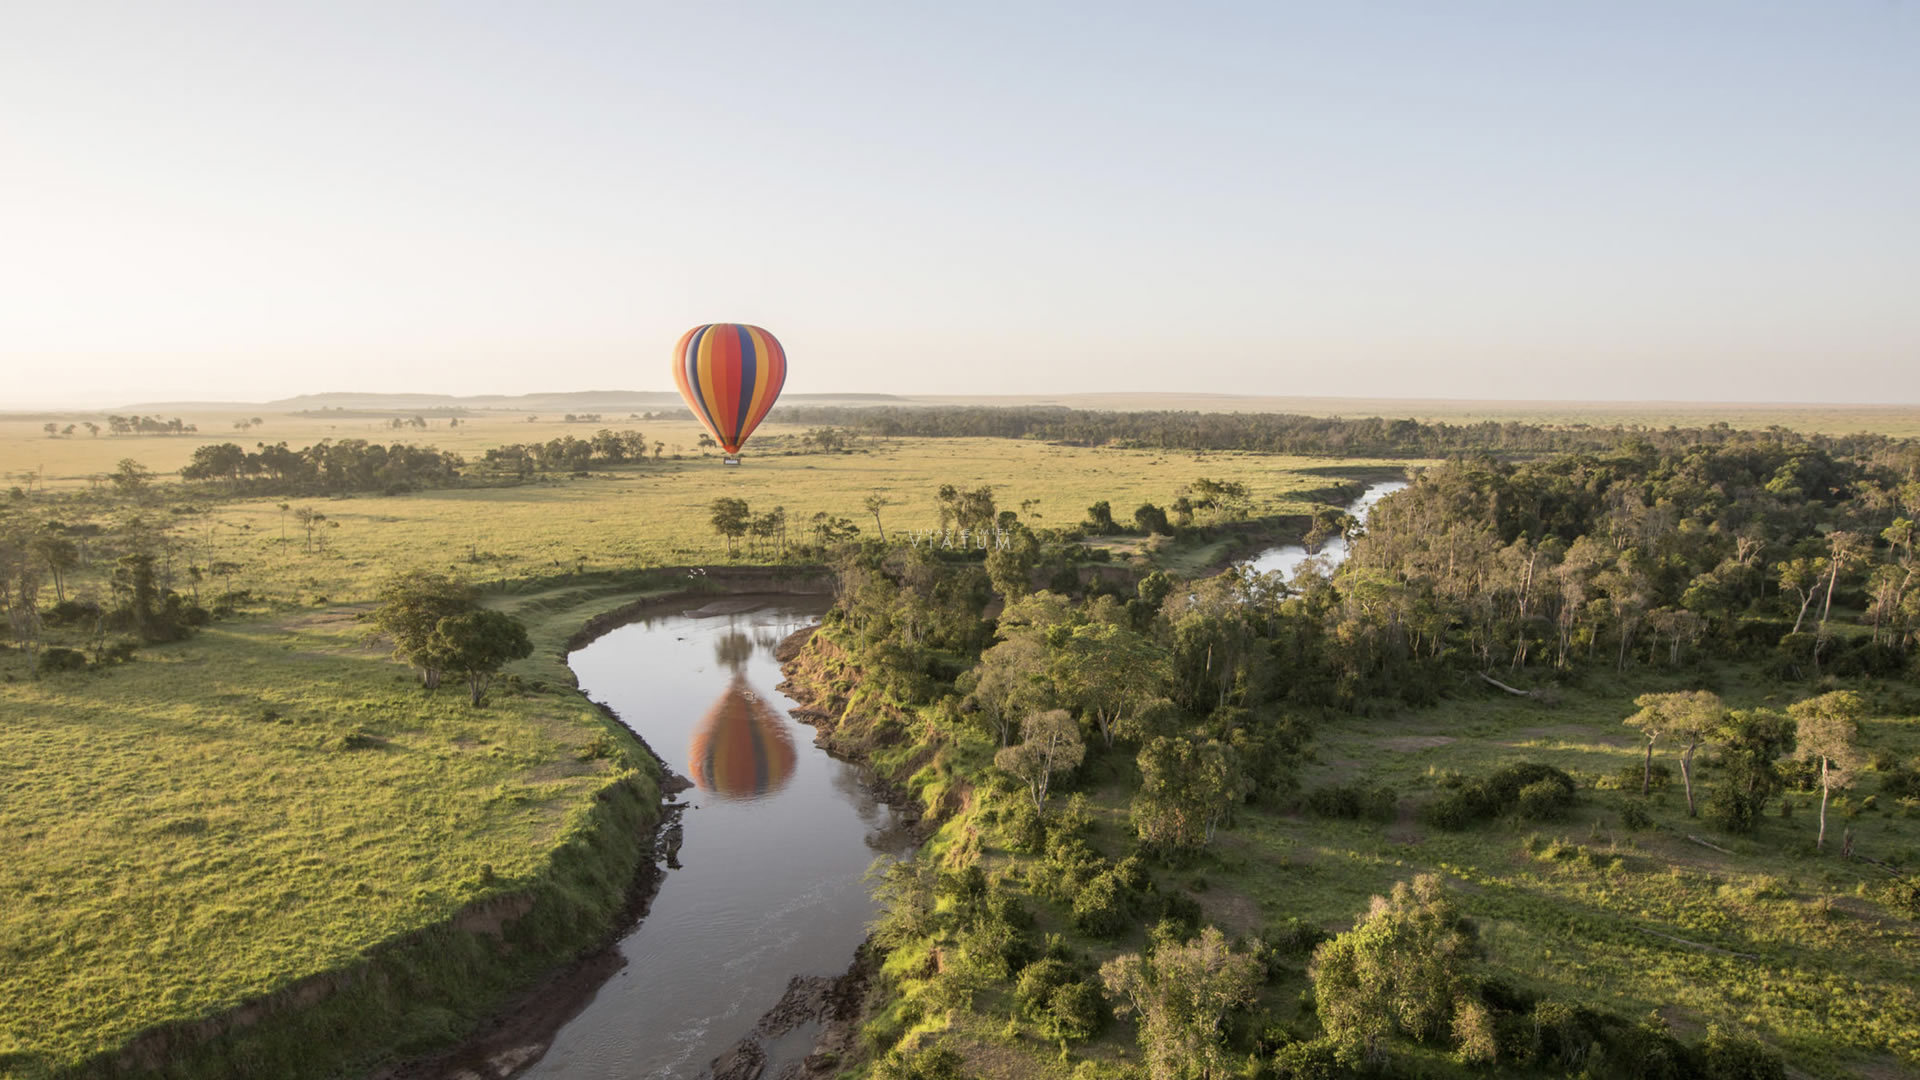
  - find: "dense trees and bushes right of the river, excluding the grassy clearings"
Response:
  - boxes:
[791,434,1920,1080]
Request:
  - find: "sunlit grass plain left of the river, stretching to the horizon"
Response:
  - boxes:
[0,405,1400,1078]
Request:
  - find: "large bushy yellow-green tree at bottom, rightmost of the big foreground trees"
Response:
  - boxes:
[1308,874,1478,1065]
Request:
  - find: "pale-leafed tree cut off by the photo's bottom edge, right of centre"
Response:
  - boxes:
[1100,926,1263,1080]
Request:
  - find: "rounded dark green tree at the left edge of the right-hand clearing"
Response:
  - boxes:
[1129,736,1252,851]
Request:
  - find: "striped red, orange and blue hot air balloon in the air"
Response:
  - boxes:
[674,323,787,465]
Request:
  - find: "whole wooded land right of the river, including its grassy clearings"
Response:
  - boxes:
[768,420,1920,1080]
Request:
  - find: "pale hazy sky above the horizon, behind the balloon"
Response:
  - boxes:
[0,0,1920,407]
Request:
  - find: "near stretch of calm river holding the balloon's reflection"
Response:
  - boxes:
[526,598,912,1080]
